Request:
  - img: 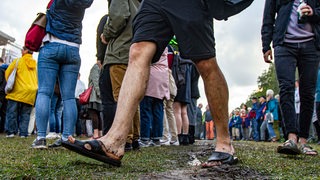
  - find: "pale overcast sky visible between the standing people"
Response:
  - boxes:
[0,0,268,111]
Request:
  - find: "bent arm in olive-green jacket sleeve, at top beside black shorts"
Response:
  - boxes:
[103,0,130,42]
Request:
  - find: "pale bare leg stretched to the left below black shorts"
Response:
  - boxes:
[100,42,156,157]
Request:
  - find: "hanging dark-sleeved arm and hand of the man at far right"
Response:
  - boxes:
[261,0,276,63]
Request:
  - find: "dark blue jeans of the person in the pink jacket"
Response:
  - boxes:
[140,96,164,140]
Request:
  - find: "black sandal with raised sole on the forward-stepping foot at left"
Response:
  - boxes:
[61,140,122,167]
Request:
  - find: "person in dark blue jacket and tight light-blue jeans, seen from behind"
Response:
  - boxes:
[31,0,93,149]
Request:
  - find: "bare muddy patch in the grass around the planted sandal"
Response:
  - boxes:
[140,141,270,180]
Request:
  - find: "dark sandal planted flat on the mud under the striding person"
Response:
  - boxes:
[202,151,239,168]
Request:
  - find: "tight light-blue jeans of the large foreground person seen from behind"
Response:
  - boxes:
[36,43,81,140]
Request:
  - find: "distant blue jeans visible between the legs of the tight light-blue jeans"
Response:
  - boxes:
[49,94,63,133]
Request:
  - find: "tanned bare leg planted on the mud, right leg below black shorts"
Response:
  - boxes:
[196,58,234,154]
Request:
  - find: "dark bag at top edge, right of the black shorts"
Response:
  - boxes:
[208,0,254,20]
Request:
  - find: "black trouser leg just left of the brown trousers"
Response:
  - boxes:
[99,65,117,134]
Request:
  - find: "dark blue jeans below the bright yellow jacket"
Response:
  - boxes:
[6,100,32,136]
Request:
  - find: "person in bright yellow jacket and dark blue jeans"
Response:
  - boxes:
[5,47,38,138]
